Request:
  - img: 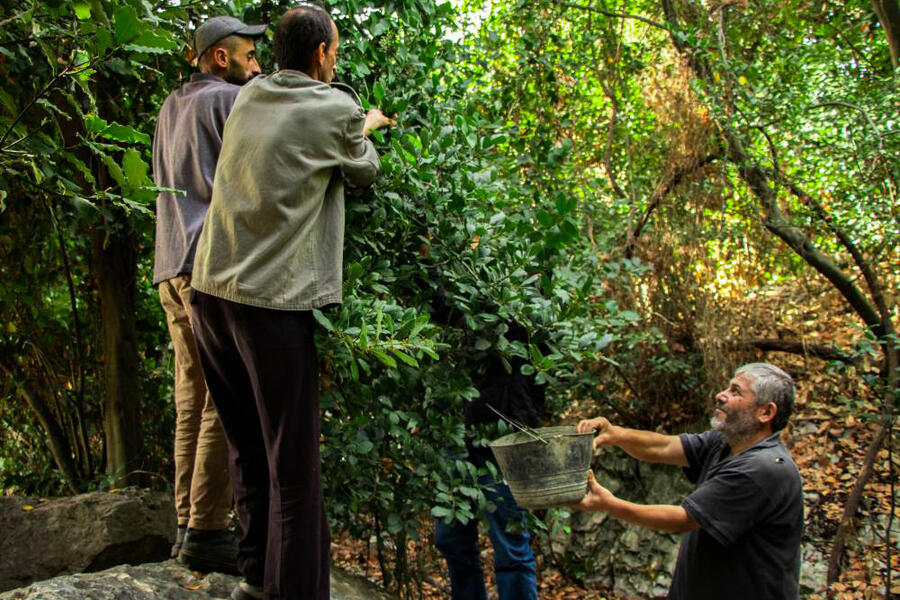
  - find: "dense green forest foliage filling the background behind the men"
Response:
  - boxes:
[0,0,900,586]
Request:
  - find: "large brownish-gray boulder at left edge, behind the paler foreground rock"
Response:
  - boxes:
[0,488,176,591]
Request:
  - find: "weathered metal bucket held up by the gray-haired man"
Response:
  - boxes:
[491,425,594,509]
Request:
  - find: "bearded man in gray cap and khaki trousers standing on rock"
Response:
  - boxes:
[153,17,266,572]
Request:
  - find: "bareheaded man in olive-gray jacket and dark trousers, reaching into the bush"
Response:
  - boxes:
[193,6,392,600]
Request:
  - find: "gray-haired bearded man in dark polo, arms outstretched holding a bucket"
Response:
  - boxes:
[575,363,803,600]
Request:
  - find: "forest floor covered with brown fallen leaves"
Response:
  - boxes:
[332,375,900,600]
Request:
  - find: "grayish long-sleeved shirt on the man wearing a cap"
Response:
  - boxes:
[153,73,241,285]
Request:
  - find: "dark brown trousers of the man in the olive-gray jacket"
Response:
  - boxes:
[193,292,331,600]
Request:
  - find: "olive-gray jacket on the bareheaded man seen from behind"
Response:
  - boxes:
[191,70,381,310]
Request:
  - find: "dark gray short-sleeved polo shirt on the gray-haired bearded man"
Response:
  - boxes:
[669,431,803,600]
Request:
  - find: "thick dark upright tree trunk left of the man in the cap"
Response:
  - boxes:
[91,218,142,486]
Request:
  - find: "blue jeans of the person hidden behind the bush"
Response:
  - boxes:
[434,448,537,600]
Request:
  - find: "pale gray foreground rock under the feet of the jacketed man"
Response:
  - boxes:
[0,560,396,600]
